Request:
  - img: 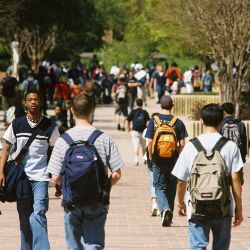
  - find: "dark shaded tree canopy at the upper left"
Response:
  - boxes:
[0,0,104,70]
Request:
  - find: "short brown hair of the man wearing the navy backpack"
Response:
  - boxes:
[72,93,95,118]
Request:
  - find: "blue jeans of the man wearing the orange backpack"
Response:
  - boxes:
[153,161,177,213]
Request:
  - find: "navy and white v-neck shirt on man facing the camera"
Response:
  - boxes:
[3,116,60,181]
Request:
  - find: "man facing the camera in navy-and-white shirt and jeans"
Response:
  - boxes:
[0,90,60,250]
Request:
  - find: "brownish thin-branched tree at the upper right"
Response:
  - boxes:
[182,0,250,117]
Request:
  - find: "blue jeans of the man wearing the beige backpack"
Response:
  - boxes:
[189,217,232,250]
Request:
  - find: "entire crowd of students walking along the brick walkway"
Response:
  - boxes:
[0,55,247,250]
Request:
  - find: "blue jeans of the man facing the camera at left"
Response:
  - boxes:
[17,181,50,250]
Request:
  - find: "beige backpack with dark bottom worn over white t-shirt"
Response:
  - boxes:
[189,137,230,220]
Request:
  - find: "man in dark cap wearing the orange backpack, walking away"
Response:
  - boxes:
[145,95,188,227]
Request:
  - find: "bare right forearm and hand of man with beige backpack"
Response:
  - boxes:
[231,173,243,226]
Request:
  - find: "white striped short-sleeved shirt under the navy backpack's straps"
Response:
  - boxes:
[47,126,124,175]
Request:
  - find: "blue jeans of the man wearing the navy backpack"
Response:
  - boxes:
[64,203,108,250]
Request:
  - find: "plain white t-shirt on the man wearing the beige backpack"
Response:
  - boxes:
[172,132,243,219]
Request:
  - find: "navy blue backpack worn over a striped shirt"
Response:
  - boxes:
[62,130,111,208]
